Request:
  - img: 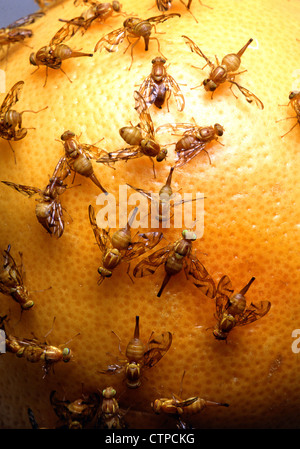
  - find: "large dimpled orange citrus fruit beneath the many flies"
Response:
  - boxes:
[0,0,300,428]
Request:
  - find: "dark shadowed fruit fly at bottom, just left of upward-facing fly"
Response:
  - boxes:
[50,391,100,429]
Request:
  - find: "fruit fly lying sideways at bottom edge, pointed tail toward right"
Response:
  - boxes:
[151,371,229,422]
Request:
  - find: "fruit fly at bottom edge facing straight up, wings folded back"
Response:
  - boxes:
[97,387,126,429]
